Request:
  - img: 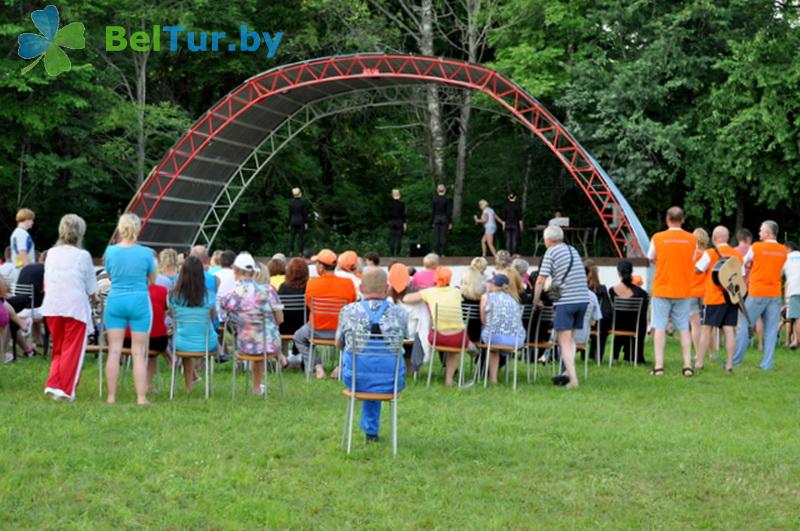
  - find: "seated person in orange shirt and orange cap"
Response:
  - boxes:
[292,249,356,380]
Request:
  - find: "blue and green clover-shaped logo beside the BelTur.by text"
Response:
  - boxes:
[17,6,86,77]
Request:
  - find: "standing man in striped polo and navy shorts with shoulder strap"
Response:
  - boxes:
[533,225,589,388]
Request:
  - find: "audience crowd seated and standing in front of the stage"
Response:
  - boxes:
[0,205,800,438]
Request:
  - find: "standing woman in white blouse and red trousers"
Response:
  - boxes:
[42,214,97,400]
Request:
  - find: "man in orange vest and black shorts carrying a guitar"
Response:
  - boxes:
[694,226,742,372]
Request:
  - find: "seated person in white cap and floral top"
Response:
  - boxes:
[220,253,286,395]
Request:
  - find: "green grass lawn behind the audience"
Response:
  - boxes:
[0,343,800,529]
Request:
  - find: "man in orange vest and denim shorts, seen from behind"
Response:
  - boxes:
[647,207,697,376]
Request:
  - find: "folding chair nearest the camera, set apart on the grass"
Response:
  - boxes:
[342,334,403,456]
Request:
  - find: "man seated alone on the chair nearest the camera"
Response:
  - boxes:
[336,266,408,443]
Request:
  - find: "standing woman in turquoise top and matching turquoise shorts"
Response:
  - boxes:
[103,214,156,406]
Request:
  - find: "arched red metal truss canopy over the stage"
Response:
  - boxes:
[127,54,649,256]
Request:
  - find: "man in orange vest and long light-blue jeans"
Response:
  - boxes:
[733,220,788,370]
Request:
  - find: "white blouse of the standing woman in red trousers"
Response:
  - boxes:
[42,245,97,334]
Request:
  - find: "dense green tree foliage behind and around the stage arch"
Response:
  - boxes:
[0,0,800,254]
